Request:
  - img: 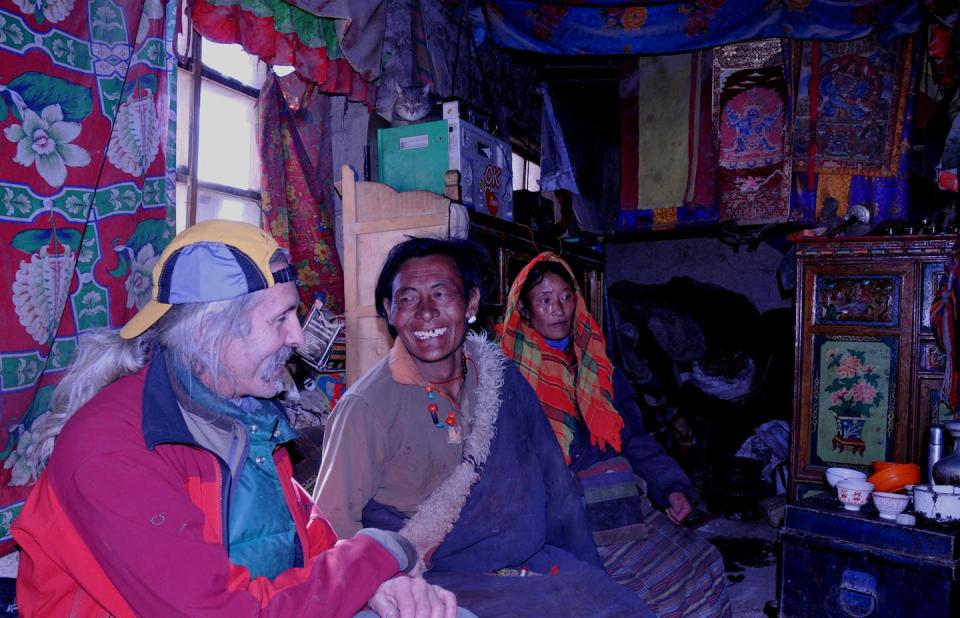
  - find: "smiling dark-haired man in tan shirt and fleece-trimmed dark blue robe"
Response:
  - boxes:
[316,238,651,617]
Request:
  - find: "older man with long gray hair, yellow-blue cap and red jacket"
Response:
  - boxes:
[13,221,457,618]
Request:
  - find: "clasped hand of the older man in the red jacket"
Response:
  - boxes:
[367,575,457,618]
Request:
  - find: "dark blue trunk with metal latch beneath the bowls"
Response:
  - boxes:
[780,496,960,618]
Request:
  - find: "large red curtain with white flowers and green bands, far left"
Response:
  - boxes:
[0,0,177,550]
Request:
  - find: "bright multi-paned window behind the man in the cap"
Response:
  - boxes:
[176,22,268,231]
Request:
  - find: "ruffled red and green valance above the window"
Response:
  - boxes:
[193,0,377,108]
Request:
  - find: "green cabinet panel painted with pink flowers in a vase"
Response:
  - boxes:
[810,336,897,466]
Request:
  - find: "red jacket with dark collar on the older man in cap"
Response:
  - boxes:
[13,358,399,618]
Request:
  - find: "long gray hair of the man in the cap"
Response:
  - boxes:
[4,250,287,484]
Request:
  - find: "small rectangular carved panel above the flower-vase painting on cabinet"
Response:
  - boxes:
[814,275,900,326]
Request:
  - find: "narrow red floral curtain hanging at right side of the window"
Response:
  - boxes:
[257,73,343,314]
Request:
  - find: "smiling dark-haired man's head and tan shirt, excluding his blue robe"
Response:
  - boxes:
[315,238,483,535]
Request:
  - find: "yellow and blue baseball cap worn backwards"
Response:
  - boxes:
[120,219,296,339]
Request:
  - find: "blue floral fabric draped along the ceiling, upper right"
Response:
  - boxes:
[473,0,923,55]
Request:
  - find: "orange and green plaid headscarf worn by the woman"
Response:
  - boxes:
[500,252,623,463]
